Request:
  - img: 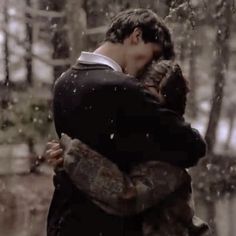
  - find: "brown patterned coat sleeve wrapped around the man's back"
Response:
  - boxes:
[61,136,191,216]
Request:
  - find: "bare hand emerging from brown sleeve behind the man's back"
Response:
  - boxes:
[44,140,64,168]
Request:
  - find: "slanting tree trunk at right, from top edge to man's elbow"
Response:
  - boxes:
[205,0,232,153]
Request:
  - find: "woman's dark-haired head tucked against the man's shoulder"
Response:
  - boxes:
[142,60,189,115]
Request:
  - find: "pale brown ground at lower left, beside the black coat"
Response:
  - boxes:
[0,167,53,236]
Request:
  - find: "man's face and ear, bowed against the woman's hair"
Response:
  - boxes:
[125,29,161,76]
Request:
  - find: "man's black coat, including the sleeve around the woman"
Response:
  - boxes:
[47,61,205,236]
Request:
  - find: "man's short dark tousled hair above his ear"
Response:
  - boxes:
[105,9,175,60]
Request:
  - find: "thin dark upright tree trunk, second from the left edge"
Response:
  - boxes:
[25,0,33,85]
